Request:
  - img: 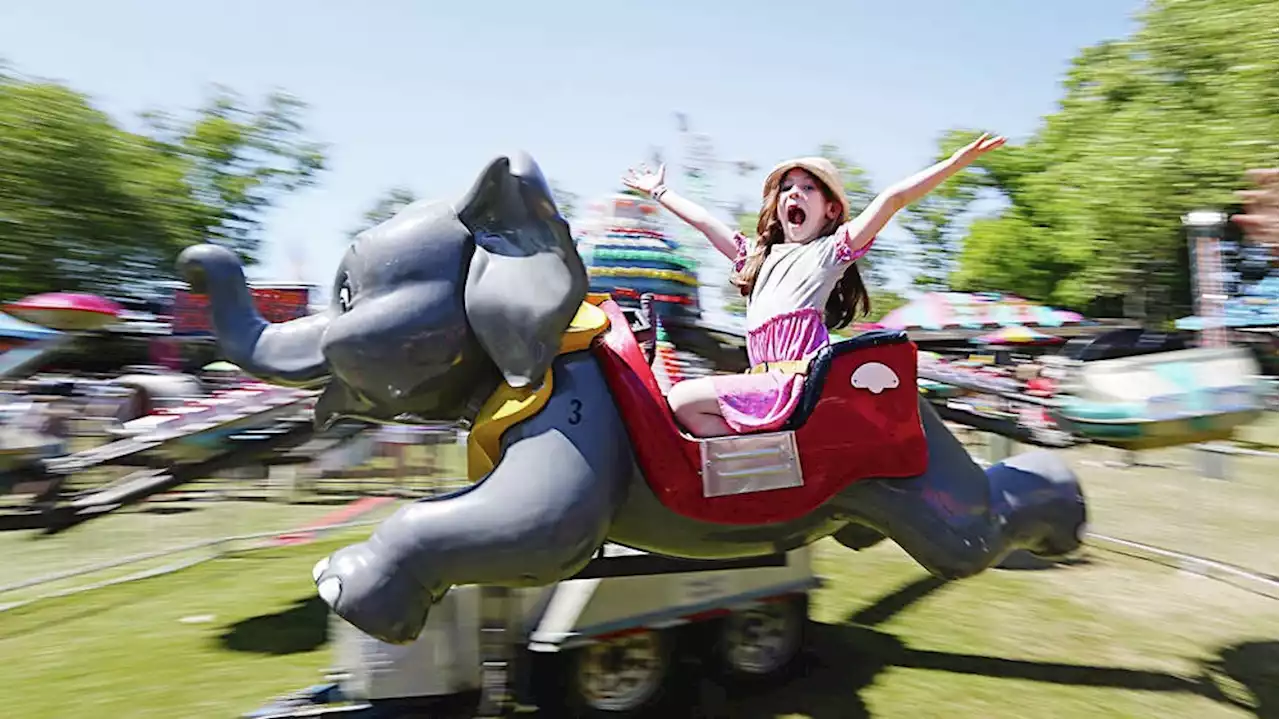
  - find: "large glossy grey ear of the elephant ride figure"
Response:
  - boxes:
[457,155,588,389]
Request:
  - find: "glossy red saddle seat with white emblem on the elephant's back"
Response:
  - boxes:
[593,299,928,525]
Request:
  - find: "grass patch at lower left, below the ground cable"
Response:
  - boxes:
[0,532,362,719]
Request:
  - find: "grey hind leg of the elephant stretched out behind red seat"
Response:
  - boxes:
[836,399,1085,578]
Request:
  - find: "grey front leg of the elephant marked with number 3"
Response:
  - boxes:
[314,353,634,644]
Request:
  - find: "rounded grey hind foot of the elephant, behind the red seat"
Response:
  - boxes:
[987,452,1088,559]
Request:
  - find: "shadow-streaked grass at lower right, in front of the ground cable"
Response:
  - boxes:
[727,544,1280,719]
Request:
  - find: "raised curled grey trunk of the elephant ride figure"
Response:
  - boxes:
[178,244,330,386]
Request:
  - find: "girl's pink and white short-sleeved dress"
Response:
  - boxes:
[712,225,872,434]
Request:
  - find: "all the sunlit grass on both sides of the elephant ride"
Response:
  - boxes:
[0,427,1280,719]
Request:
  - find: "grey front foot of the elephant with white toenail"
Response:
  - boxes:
[311,541,435,644]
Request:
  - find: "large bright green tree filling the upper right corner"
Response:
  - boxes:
[954,0,1280,319]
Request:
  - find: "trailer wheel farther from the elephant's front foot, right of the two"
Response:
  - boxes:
[718,595,809,683]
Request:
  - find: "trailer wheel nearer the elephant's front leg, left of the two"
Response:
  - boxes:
[564,629,673,718]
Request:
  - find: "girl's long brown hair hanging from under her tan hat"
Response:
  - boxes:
[730,170,872,330]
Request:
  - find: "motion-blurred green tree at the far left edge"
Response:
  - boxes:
[0,70,200,298]
